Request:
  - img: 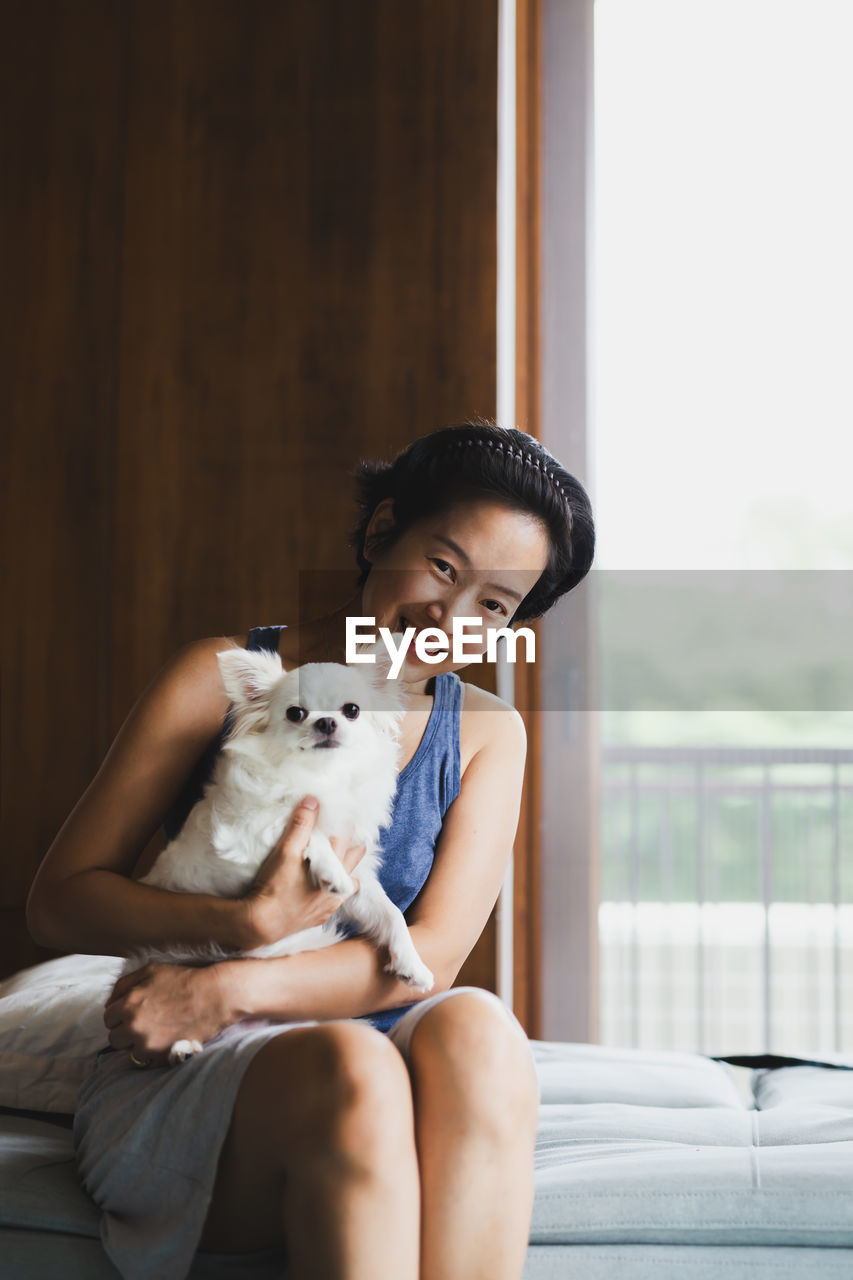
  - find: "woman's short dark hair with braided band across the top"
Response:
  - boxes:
[352,422,596,622]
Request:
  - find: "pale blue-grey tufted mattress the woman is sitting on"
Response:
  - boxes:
[0,1042,853,1280]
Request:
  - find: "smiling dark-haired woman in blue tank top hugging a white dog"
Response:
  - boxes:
[28,425,593,1280]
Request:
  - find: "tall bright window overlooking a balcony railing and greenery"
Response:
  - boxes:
[590,0,853,1053]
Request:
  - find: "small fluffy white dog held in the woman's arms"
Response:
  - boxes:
[124,649,433,1062]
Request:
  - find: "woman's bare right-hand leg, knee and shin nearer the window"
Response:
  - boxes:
[401,988,539,1280]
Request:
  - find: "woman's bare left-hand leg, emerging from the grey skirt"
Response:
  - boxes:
[200,1023,420,1280]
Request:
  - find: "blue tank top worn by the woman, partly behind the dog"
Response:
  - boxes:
[163,627,462,1032]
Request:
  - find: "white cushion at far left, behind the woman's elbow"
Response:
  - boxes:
[0,955,124,1112]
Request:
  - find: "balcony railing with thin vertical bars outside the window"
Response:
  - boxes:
[599,748,853,1055]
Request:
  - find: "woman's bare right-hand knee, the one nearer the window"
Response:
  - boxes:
[410,988,539,1133]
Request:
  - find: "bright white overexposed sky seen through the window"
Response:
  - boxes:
[592,0,853,570]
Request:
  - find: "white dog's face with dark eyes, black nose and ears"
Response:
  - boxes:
[218,649,402,760]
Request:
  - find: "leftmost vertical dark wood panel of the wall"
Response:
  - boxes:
[0,3,126,972]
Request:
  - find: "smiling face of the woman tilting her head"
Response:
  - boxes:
[361,498,549,684]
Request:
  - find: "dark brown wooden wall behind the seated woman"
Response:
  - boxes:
[0,0,497,984]
